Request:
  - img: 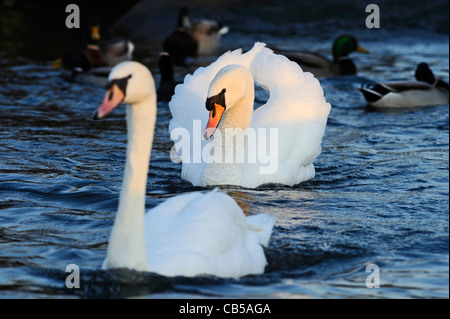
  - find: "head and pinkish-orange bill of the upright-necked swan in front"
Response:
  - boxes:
[93,61,155,120]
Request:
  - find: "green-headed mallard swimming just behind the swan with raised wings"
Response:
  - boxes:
[275,35,369,77]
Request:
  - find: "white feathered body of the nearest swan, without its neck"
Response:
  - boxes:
[145,191,275,277]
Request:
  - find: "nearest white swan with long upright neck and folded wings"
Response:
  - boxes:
[93,62,275,277]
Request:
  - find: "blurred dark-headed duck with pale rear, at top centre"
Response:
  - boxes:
[163,7,229,65]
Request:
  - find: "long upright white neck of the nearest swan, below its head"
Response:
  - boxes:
[107,96,156,271]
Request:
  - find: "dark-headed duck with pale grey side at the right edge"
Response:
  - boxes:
[359,62,449,108]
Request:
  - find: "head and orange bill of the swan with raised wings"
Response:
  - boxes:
[203,64,254,140]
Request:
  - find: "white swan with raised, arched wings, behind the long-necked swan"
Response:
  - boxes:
[169,43,331,188]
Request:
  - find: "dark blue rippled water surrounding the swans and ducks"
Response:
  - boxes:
[0,13,449,298]
